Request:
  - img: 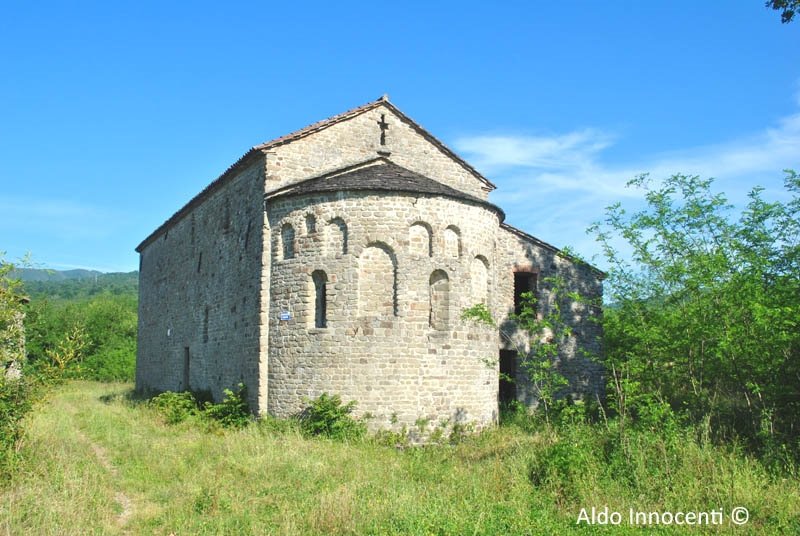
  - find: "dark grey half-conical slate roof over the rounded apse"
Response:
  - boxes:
[267,157,505,221]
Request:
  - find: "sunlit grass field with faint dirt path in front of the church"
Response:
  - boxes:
[0,382,800,535]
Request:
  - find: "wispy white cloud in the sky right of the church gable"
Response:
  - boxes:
[454,96,800,266]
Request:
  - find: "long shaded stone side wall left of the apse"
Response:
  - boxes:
[136,164,266,407]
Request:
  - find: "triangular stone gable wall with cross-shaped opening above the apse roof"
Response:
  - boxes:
[266,106,488,199]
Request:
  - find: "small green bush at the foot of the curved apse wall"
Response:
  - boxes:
[300,393,366,440]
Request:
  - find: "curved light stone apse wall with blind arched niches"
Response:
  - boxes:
[268,188,499,429]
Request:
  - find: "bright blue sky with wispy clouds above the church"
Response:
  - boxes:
[0,0,800,271]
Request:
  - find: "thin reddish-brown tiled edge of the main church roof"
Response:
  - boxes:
[136,95,496,253]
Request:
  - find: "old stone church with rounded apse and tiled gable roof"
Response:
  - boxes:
[136,97,603,429]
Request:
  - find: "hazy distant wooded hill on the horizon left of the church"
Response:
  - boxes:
[14,268,139,300]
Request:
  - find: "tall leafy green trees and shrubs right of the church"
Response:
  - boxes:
[592,172,800,456]
